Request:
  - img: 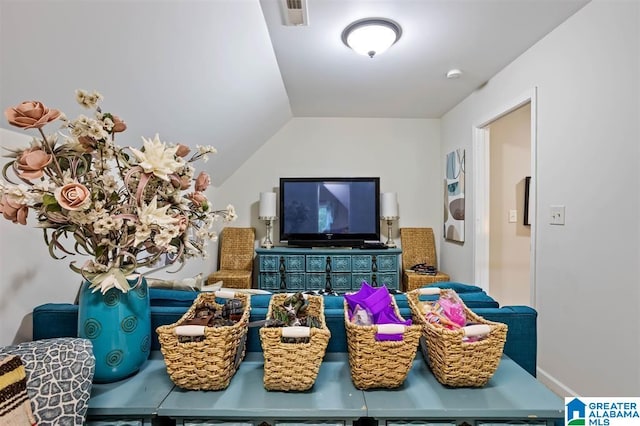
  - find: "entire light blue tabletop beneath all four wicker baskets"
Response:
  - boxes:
[88,352,564,426]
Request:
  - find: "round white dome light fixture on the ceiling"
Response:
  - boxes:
[342,18,402,58]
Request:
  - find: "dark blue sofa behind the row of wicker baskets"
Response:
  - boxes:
[33,283,537,376]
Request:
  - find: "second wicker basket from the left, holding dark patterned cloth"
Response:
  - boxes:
[260,293,331,391]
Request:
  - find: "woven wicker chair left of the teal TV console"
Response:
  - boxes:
[207,227,256,288]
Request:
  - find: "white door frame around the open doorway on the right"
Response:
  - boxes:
[472,87,538,308]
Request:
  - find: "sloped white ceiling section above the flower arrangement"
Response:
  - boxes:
[0,0,291,185]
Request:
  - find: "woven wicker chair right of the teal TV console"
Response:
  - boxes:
[400,228,450,291]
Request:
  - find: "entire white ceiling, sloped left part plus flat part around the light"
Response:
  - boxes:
[0,0,588,185]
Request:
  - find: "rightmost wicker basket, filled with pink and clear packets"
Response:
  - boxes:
[407,287,507,387]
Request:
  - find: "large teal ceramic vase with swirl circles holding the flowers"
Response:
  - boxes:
[78,277,151,383]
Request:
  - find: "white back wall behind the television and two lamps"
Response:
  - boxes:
[215,118,442,244]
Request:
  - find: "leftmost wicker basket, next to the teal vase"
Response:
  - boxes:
[156,291,251,390]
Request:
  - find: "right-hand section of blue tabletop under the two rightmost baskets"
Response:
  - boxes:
[364,356,564,424]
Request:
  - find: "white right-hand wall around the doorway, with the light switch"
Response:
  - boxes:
[441,0,640,396]
